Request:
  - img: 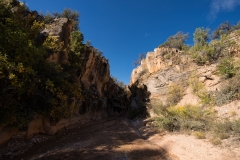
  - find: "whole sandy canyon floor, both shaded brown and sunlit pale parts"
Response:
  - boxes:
[0,117,240,160]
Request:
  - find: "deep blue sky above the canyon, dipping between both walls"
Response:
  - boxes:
[24,0,240,84]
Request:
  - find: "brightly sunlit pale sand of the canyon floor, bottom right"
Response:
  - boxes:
[148,134,240,160]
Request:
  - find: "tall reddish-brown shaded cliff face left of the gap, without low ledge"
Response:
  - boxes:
[79,47,128,114]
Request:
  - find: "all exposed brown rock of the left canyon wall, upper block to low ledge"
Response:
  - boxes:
[0,18,129,146]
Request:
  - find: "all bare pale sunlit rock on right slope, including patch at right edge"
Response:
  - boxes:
[130,30,240,116]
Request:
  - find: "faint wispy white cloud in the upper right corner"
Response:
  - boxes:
[210,0,240,19]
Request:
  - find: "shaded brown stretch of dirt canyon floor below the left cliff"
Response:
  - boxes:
[2,118,172,160]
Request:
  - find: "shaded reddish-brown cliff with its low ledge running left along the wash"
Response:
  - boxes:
[11,47,129,144]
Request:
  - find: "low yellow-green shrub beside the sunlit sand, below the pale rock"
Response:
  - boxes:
[154,105,214,131]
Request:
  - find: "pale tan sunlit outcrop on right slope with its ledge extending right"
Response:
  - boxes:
[130,47,219,106]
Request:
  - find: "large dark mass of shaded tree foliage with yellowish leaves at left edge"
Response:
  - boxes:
[0,2,83,125]
